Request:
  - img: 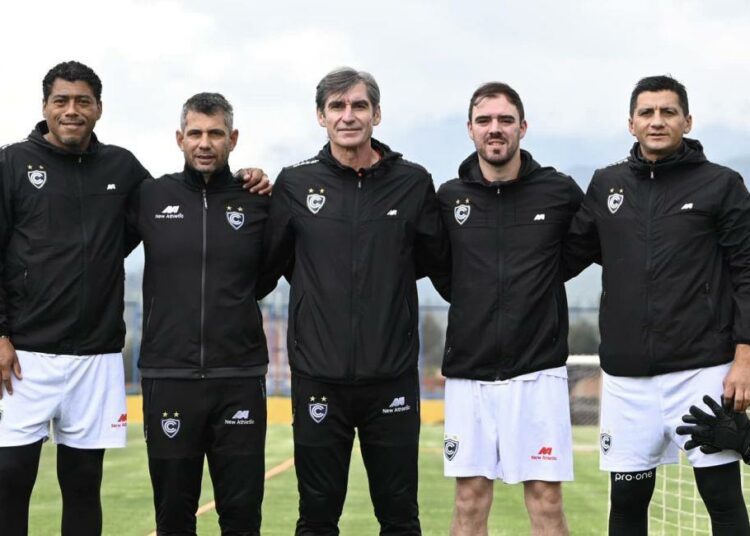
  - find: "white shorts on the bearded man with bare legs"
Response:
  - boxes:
[443,367,573,484]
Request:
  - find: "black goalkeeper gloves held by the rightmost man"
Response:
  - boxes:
[676,395,750,463]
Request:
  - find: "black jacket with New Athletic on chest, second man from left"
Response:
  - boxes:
[128,166,273,379]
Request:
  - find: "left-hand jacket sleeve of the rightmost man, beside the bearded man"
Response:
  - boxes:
[561,175,602,281]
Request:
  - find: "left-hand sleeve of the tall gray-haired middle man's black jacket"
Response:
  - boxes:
[256,171,294,300]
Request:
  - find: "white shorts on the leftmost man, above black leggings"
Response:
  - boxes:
[0,350,128,449]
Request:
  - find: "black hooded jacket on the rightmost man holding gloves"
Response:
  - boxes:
[565,139,750,376]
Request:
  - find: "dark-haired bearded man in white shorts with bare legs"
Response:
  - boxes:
[438,82,583,536]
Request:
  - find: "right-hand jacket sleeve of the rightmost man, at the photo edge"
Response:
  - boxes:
[716,174,750,344]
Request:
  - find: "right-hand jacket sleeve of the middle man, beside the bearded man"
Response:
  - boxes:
[414,175,451,301]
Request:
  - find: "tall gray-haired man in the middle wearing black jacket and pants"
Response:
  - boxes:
[263,68,448,535]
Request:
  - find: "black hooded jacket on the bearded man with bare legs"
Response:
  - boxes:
[438,151,583,381]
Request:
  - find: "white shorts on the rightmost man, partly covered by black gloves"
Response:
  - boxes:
[599,363,740,472]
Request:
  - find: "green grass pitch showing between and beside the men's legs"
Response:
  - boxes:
[30,425,607,536]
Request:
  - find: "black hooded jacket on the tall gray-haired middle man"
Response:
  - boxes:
[264,140,449,383]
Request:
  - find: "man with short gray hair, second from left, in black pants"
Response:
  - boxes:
[128,93,273,534]
